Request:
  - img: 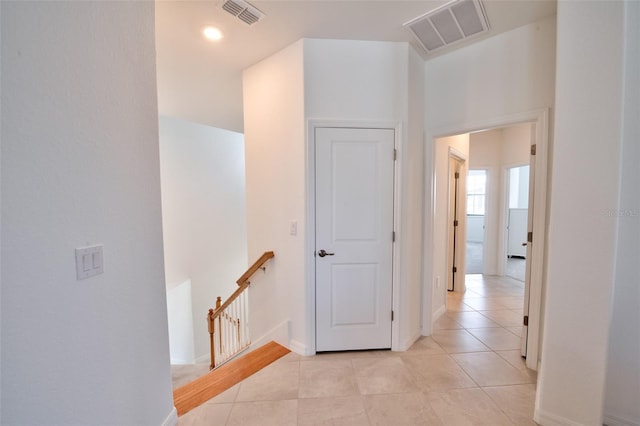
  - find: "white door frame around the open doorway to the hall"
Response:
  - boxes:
[422,108,549,370]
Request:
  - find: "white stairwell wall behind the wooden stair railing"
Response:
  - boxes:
[160,117,247,359]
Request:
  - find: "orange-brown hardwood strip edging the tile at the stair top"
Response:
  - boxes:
[173,342,291,416]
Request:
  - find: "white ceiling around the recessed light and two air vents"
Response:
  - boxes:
[156,0,556,132]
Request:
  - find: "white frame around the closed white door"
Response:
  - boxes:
[305,119,402,355]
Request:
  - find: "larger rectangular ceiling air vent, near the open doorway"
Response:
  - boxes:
[404,0,489,53]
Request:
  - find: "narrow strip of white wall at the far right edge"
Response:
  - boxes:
[605,2,640,426]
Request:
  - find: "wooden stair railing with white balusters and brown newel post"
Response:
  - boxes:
[207,251,275,370]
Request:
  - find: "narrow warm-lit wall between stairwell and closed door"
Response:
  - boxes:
[243,41,308,353]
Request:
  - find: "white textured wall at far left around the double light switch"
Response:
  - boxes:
[0,1,175,425]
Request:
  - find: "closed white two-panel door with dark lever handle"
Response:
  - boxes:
[315,128,395,352]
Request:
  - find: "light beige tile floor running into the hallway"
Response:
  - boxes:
[179,275,536,426]
